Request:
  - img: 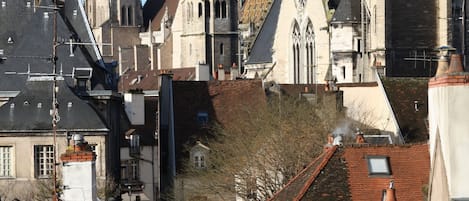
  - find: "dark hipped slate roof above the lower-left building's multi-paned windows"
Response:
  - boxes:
[0,81,108,133]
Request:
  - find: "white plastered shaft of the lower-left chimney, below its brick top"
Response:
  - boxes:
[62,161,97,201]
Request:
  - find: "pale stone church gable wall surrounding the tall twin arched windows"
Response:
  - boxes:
[268,1,330,84]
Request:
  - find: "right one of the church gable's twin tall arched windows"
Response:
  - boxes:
[305,21,315,84]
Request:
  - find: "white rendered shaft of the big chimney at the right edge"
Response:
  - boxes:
[428,85,469,198]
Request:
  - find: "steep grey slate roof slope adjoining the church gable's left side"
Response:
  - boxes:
[246,0,282,64]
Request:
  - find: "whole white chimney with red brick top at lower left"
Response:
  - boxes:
[60,134,97,201]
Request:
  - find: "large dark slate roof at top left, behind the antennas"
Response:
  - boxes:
[0,0,108,91]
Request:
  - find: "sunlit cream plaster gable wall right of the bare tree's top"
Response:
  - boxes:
[340,86,399,135]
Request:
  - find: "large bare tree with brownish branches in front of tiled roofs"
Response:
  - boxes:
[181,93,341,200]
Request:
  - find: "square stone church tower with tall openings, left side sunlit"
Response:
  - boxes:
[173,0,238,72]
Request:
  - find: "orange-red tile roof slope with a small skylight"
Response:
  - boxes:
[343,144,430,201]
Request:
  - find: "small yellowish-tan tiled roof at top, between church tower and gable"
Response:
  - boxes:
[240,0,274,25]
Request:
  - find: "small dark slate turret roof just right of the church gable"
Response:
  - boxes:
[331,0,361,24]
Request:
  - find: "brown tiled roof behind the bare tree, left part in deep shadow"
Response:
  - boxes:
[173,80,266,170]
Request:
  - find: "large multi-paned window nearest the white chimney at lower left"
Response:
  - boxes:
[34,145,54,178]
